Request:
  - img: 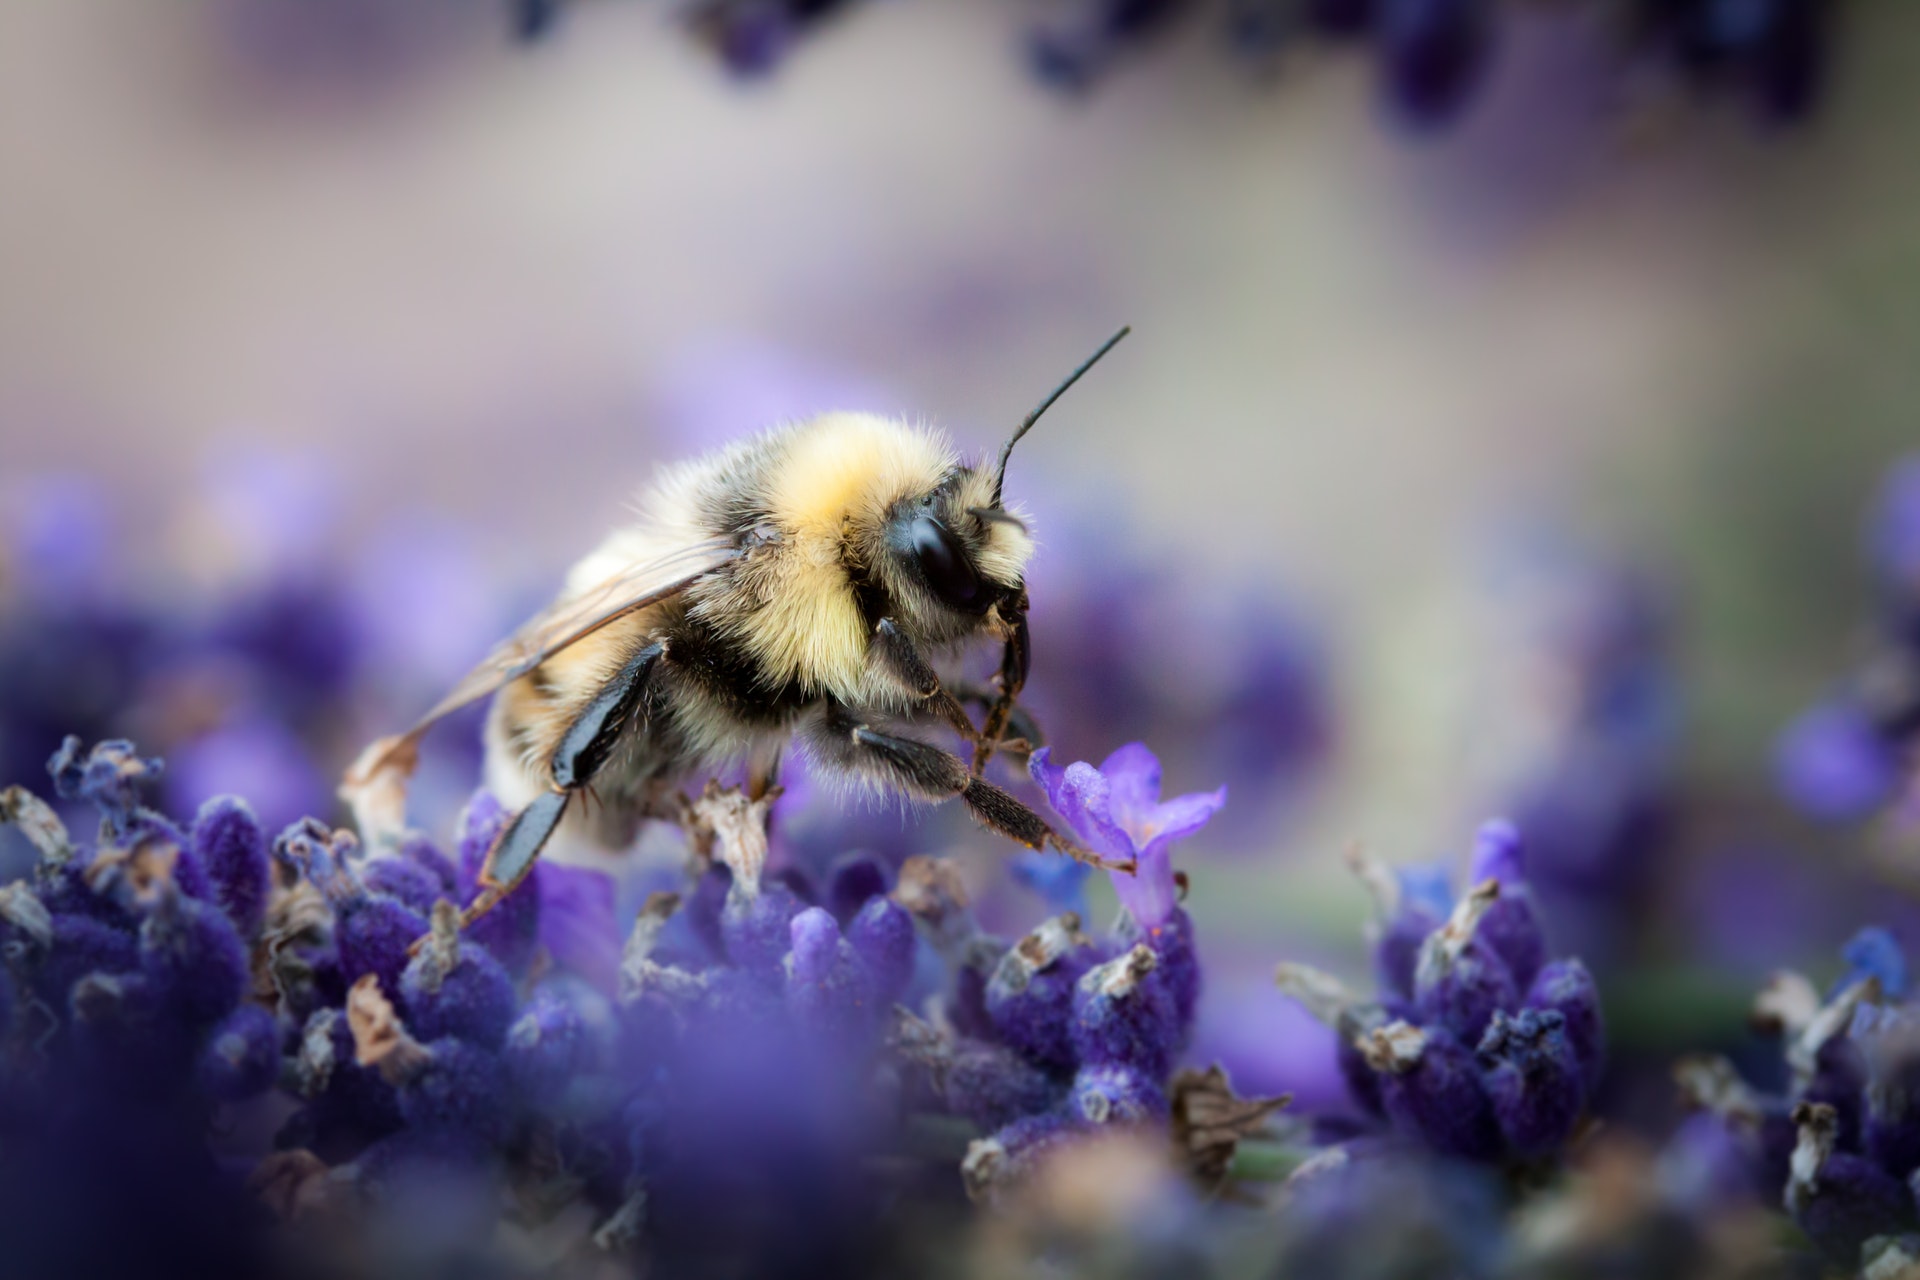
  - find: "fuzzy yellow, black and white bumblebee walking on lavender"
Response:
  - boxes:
[342,328,1131,921]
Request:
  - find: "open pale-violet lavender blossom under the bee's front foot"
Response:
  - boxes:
[1027,743,1227,929]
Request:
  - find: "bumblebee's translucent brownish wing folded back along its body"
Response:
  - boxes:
[340,537,741,802]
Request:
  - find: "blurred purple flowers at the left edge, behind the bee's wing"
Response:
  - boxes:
[0,466,516,844]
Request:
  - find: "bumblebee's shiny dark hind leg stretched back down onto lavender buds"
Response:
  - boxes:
[461,643,666,927]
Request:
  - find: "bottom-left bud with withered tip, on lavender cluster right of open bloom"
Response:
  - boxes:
[1359,1021,1501,1159]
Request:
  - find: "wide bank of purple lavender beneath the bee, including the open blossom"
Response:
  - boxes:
[0,737,1277,1274]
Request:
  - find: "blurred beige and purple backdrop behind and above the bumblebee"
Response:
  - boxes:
[0,0,1920,1143]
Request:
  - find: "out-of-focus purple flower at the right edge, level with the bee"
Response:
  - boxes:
[1776,457,1920,821]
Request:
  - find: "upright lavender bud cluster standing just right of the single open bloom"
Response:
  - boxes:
[1277,821,1605,1167]
